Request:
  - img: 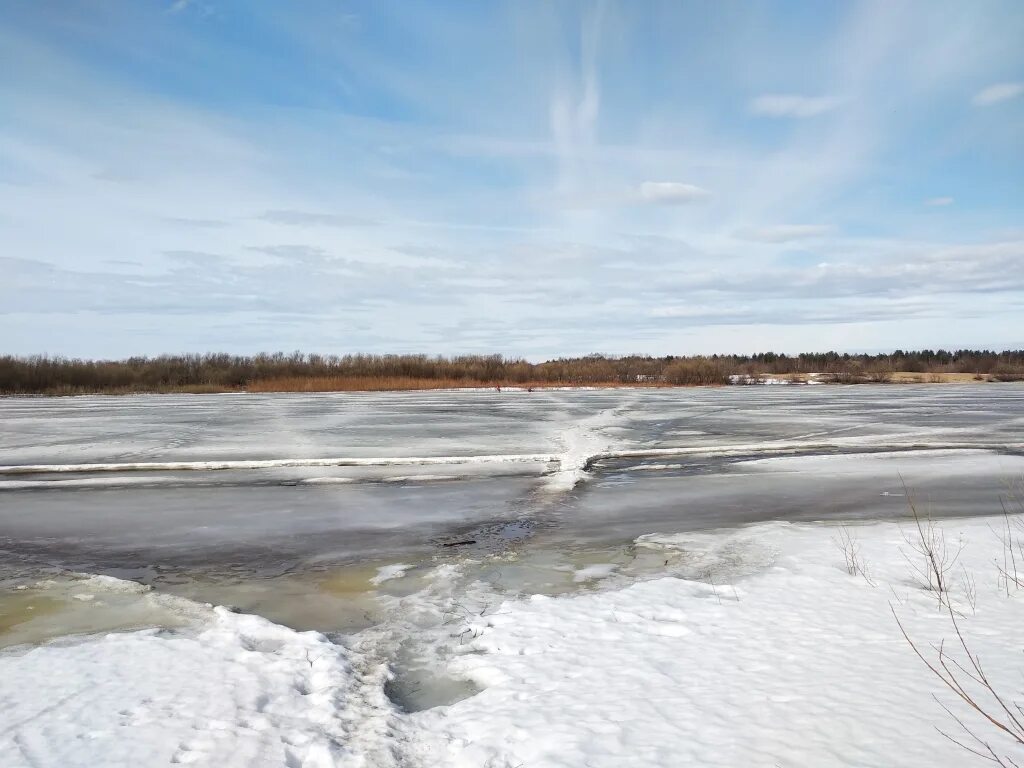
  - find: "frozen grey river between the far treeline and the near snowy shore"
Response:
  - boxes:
[0,385,1024,572]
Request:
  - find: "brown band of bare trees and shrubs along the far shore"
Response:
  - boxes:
[0,349,1024,394]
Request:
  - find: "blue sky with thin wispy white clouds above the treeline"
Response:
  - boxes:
[0,0,1024,359]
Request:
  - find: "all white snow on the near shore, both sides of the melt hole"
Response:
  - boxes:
[0,517,1024,768]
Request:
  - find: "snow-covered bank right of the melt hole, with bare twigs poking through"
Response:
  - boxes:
[407,518,1024,768]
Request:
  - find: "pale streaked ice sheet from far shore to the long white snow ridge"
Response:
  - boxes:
[0,384,1024,466]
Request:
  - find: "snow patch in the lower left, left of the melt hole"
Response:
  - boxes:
[0,608,389,768]
